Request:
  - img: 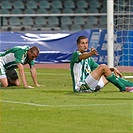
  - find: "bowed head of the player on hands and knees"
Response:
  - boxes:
[28,46,40,60]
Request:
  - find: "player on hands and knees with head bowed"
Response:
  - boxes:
[0,46,40,88]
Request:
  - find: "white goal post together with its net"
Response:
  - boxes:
[107,0,133,78]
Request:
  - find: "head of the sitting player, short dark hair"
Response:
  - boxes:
[77,36,88,53]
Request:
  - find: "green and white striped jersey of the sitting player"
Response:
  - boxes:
[70,51,98,92]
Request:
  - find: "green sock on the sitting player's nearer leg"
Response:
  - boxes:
[106,73,126,91]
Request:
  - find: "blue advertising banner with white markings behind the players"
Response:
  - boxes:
[0,29,133,66]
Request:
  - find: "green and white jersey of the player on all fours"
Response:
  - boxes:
[0,46,34,70]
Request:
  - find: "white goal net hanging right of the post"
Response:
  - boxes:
[114,0,133,78]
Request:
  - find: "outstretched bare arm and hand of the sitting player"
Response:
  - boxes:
[79,48,99,60]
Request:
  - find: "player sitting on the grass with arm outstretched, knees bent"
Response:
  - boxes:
[70,36,133,92]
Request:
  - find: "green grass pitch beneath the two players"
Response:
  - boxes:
[0,69,133,133]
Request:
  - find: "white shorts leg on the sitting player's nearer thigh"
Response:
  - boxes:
[85,74,99,90]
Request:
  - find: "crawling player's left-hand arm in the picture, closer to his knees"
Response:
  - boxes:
[17,63,33,88]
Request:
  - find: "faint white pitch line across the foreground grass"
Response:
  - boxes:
[0,100,127,107]
